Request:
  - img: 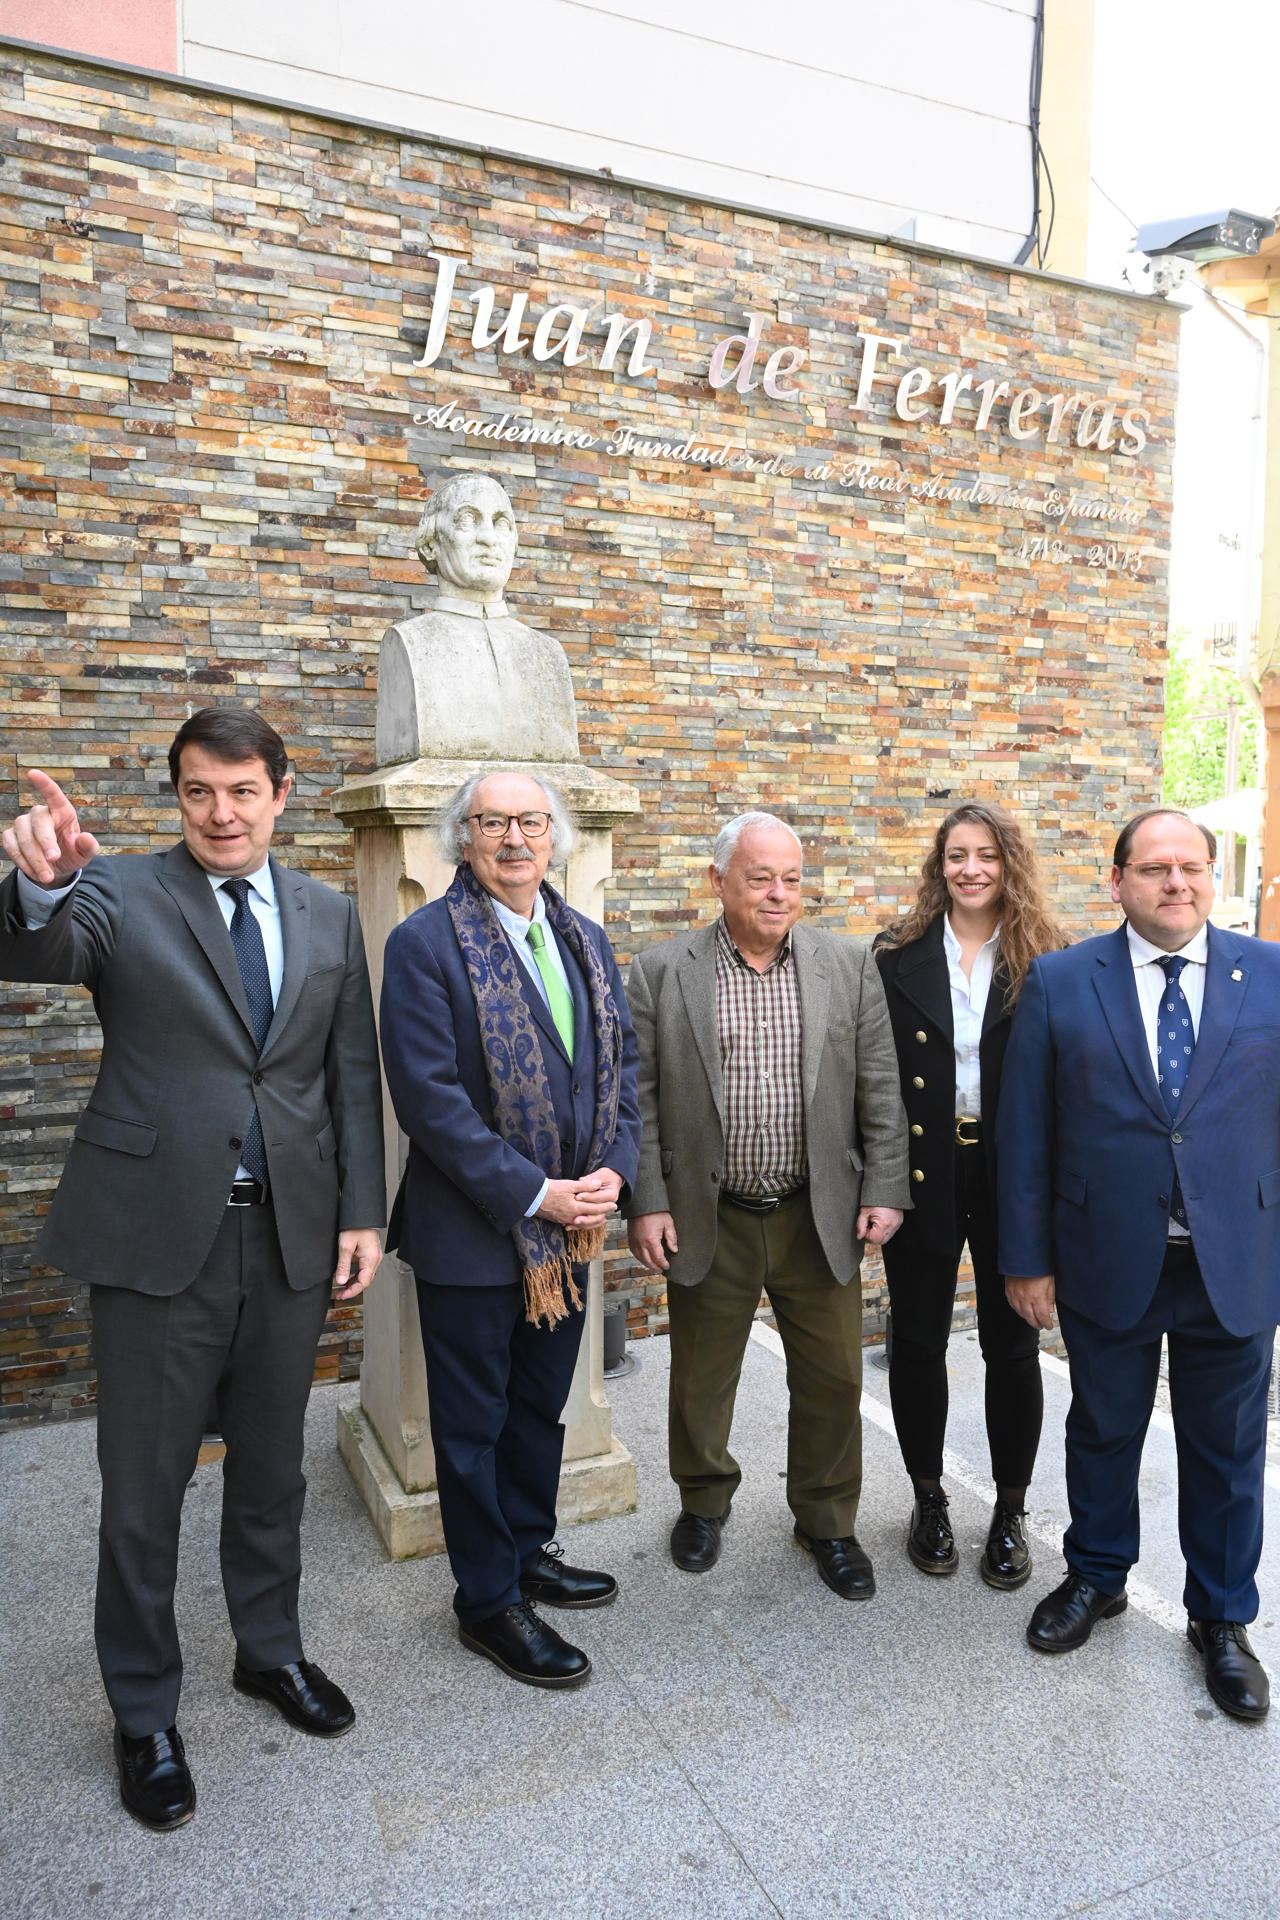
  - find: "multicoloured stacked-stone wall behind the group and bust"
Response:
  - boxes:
[0,46,1176,1419]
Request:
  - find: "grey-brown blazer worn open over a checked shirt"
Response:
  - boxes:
[628,924,912,1286]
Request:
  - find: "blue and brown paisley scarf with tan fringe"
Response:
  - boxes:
[445,862,622,1327]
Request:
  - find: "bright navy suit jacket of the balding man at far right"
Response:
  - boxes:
[998,925,1280,1336]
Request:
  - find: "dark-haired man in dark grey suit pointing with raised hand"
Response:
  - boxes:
[0,708,386,1830]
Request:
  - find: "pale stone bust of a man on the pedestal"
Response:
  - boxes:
[374,472,578,766]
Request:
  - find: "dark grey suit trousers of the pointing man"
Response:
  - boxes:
[90,1204,328,1734]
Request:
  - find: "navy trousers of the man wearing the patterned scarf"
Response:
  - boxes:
[418,1267,587,1624]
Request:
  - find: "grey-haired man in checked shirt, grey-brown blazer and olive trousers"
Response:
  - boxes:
[628,812,910,1599]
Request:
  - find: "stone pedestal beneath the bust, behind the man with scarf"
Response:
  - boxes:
[332,760,639,1559]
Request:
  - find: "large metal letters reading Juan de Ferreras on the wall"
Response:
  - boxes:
[413,253,1151,459]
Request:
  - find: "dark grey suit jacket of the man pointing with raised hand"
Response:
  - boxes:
[0,845,386,1294]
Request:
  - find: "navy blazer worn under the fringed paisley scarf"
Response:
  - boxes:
[382,899,639,1286]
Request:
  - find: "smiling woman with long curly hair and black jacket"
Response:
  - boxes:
[875,801,1067,1588]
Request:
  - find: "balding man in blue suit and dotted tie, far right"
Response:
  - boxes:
[998,808,1280,1720]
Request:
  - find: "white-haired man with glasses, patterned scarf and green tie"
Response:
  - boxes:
[382,772,639,1688]
